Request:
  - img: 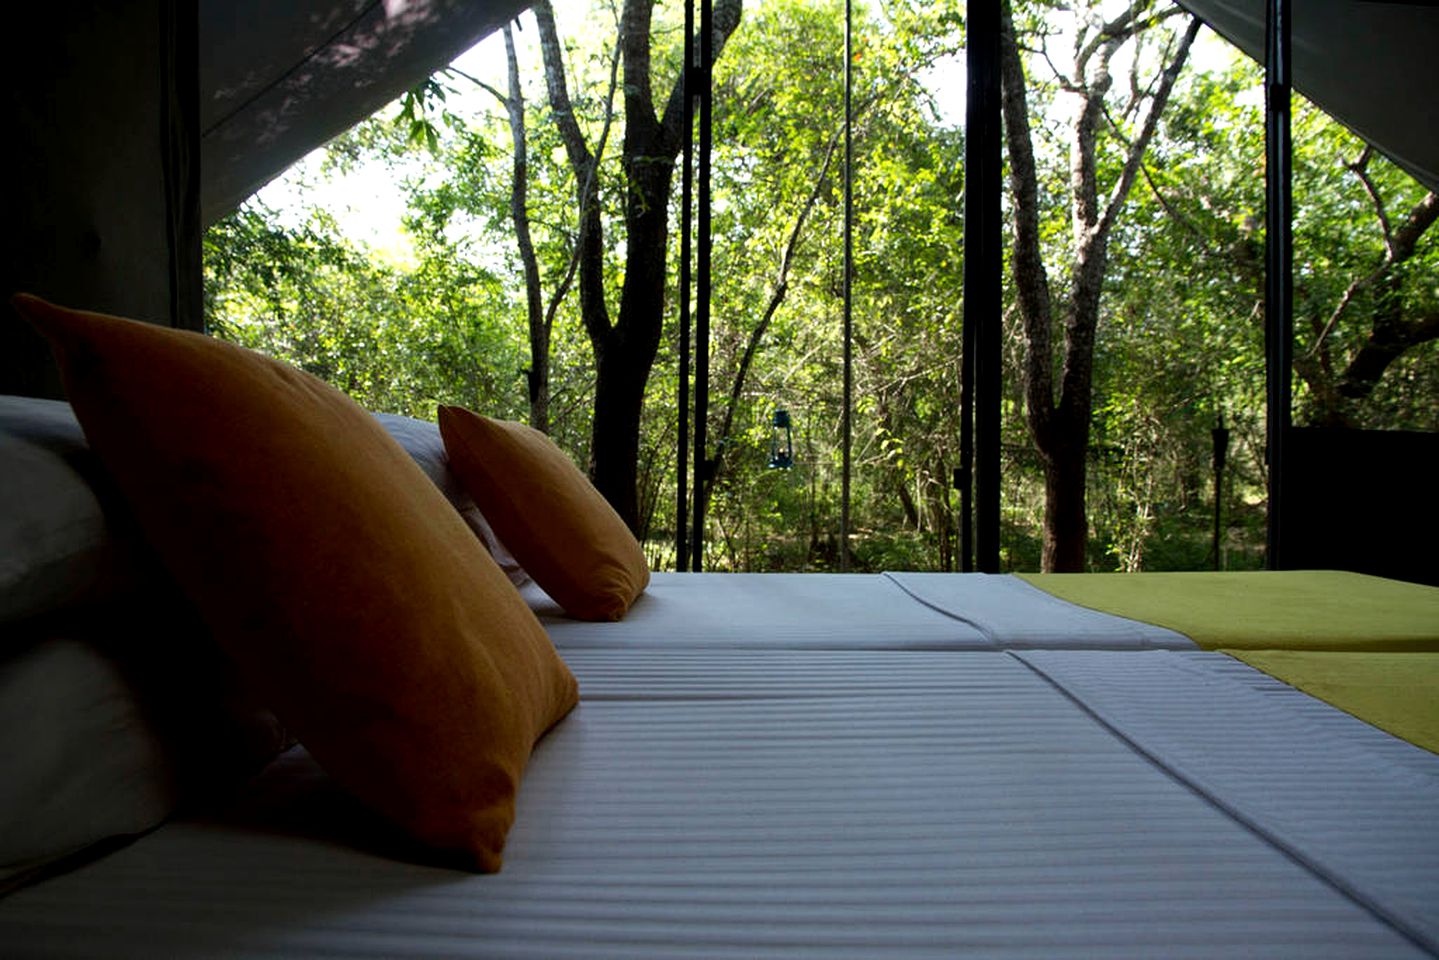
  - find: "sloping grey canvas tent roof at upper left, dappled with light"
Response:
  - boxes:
[200,0,530,225]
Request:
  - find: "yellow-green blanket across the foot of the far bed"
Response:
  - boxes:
[1019,570,1439,652]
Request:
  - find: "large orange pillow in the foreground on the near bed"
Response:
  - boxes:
[14,295,577,871]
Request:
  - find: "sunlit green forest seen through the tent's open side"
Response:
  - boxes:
[204,0,1439,571]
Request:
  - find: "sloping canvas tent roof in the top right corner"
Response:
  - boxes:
[1179,0,1439,190]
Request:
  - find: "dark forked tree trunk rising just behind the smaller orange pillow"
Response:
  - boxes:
[534,0,741,531]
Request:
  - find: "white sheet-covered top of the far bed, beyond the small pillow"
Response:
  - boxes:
[521,573,1194,651]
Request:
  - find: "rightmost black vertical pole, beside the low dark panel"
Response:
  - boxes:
[1265,0,1294,570]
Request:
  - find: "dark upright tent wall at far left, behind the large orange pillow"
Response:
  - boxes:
[0,0,201,396]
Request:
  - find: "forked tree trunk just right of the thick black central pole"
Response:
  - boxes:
[1000,0,1199,571]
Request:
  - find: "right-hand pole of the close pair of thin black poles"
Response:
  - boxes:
[689,0,714,573]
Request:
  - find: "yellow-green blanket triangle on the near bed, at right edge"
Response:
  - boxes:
[1225,651,1439,753]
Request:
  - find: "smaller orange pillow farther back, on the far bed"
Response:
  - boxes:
[439,406,649,620]
